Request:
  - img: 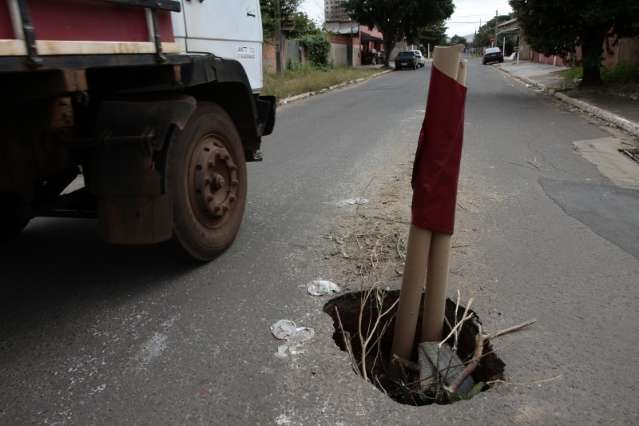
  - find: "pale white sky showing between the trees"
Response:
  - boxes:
[301,0,512,36]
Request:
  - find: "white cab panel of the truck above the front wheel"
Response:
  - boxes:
[182,0,263,92]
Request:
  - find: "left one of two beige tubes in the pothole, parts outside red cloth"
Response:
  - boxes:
[392,45,465,359]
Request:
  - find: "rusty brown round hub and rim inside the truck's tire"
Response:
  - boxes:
[187,135,240,227]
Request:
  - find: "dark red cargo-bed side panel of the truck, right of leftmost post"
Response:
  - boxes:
[28,0,174,42]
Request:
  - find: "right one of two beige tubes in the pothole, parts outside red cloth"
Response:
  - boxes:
[421,51,468,342]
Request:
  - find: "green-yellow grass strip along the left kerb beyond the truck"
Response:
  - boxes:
[263,66,379,99]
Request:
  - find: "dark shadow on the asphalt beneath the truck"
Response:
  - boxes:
[0,219,194,341]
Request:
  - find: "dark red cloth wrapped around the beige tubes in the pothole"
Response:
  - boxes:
[412,66,466,234]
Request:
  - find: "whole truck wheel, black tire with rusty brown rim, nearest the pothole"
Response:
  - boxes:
[166,102,246,261]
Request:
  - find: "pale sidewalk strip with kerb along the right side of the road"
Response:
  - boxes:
[498,61,639,136]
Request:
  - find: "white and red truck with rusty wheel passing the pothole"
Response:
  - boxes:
[0,0,276,261]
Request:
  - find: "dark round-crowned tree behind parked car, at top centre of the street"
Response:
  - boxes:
[345,0,455,66]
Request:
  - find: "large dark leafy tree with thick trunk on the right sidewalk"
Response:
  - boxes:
[510,0,639,86]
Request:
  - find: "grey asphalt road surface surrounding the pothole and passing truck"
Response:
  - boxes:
[0,63,639,425]
